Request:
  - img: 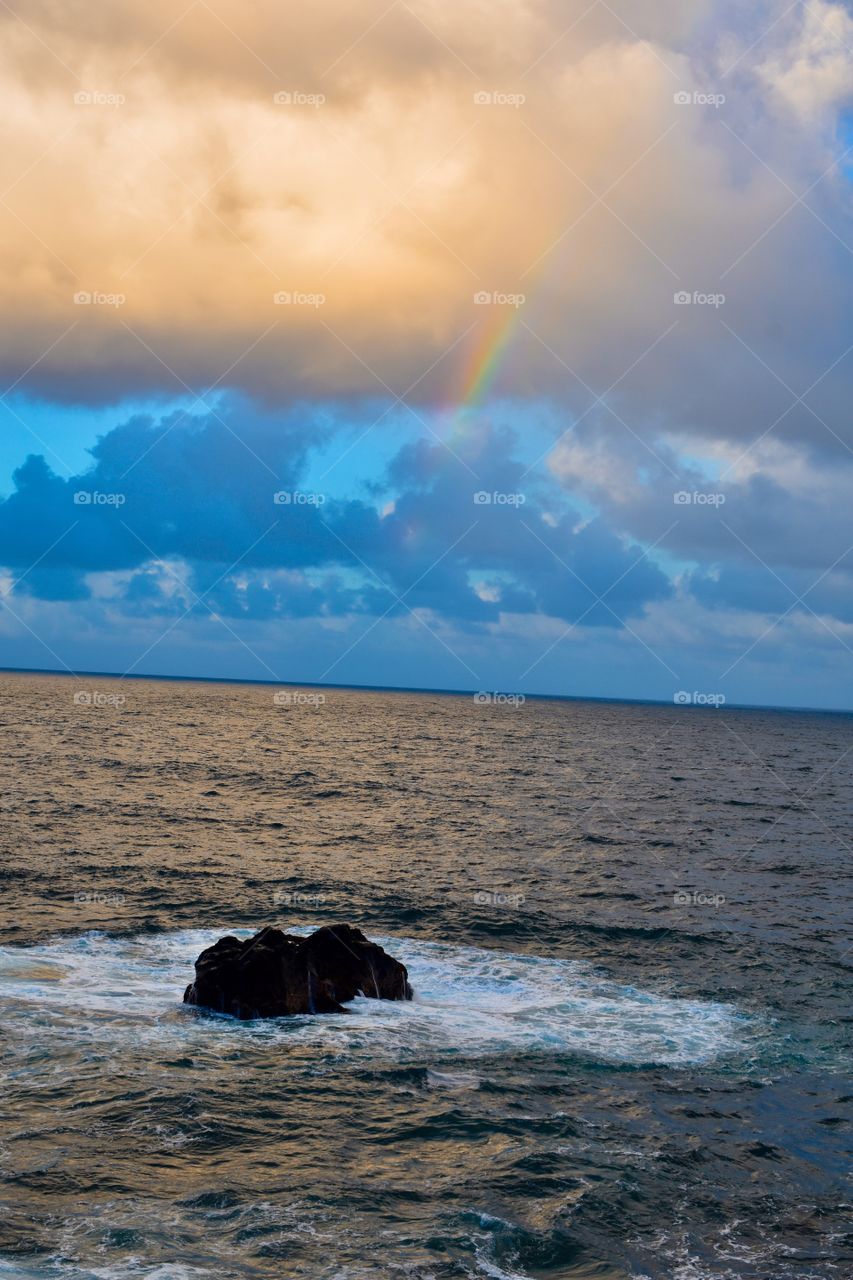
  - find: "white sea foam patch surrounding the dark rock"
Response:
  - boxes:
[0,928,747,1066]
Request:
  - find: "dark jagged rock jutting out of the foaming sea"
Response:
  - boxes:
[183,924,411,1018]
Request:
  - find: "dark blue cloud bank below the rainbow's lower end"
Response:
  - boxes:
[0,397,671,627]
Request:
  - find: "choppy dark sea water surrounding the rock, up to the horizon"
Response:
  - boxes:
[0,676,853,1280]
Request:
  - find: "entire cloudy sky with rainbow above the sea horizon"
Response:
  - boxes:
[0,0,853,708]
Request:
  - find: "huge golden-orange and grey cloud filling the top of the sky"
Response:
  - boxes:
[0,0,853,471]
